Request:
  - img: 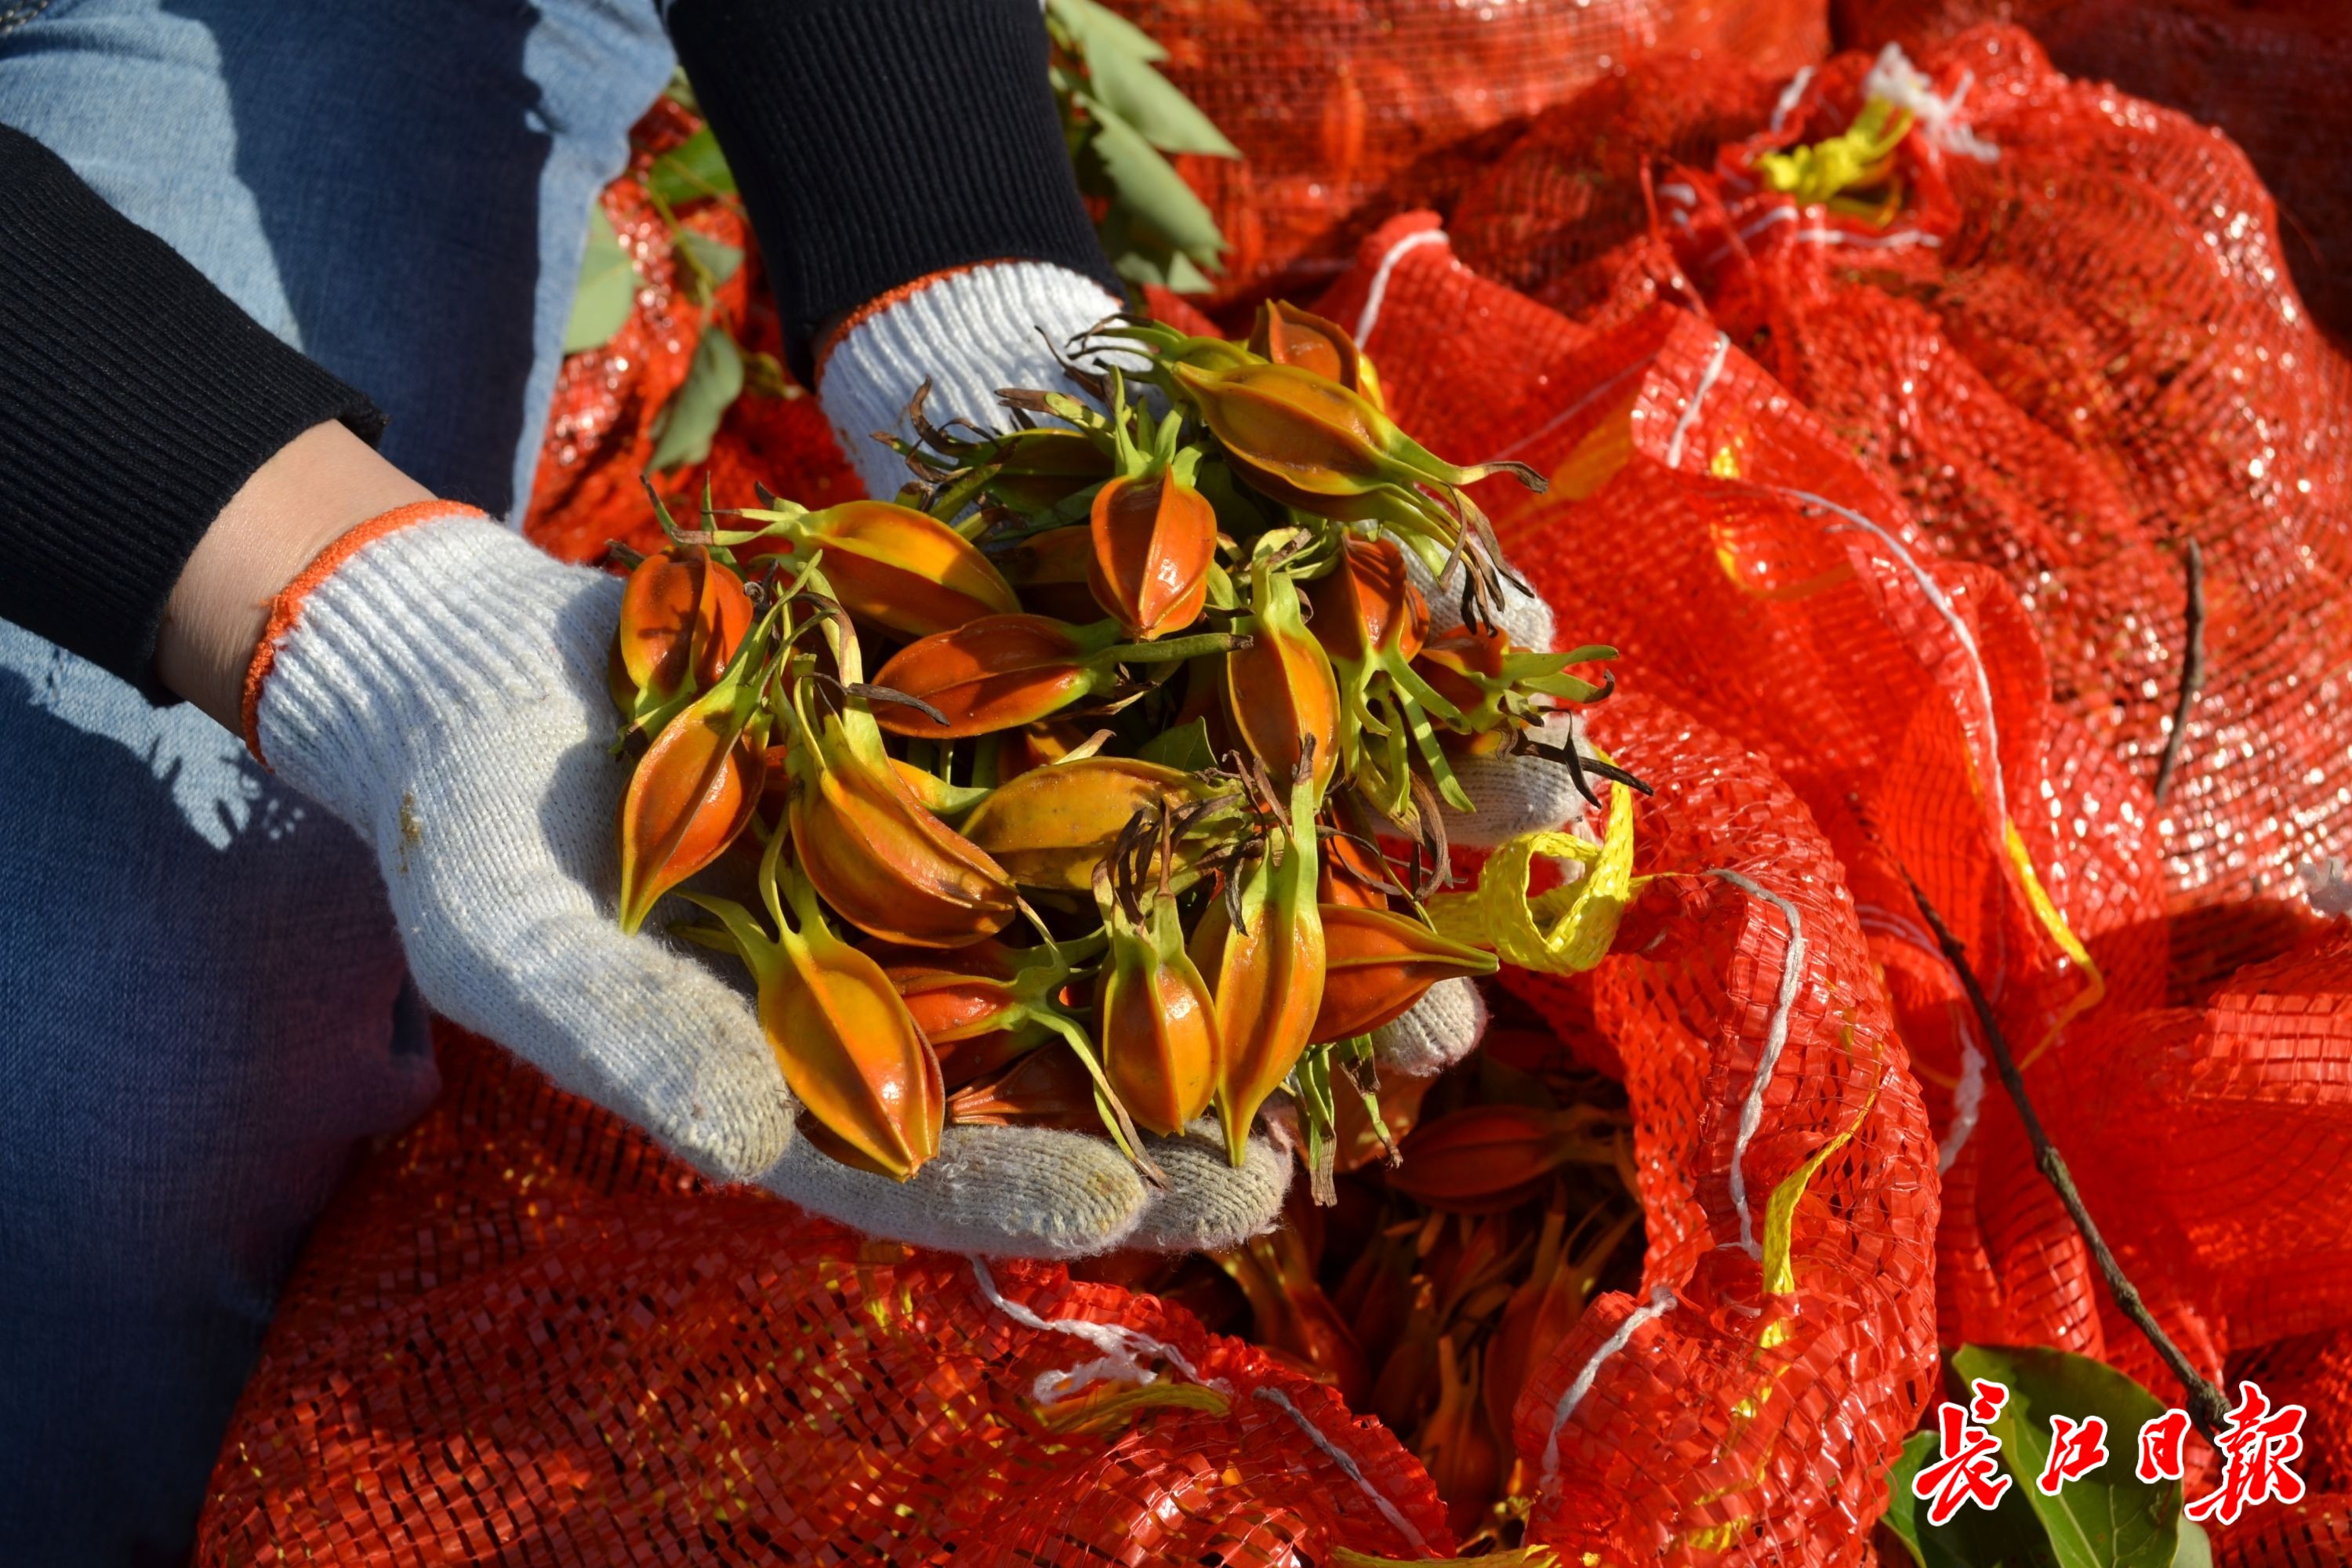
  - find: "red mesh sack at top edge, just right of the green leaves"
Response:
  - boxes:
[1112,0,1828,301]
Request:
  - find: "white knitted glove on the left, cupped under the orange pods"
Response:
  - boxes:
[247,506,1287,1258]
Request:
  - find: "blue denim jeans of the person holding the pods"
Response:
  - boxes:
[0,0,670,1566]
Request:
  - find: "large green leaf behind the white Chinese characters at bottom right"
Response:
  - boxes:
[1952,1345,2180,1568]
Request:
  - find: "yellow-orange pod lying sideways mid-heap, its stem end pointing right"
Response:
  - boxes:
[964,757,1207,891]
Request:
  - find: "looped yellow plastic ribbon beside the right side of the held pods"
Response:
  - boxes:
[1428,783,1649,975]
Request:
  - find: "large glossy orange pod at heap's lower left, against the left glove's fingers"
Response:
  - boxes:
[694,855,946,1180]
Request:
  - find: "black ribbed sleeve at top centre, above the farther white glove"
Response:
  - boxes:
[670,0,1120,379]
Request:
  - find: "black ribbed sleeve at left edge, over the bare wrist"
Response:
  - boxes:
[0,125,383,689]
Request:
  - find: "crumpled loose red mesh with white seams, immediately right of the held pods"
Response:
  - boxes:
[1319,219,2161,1561]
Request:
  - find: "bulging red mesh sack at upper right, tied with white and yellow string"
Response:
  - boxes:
[1463,28,2352,982]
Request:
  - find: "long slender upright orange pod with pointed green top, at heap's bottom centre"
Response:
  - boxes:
[1190,783,1324,1166]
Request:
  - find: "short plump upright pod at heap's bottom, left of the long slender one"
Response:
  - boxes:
[1094,898,1221,1133]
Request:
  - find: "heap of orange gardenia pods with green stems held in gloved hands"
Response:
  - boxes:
[612,306,1625,1180]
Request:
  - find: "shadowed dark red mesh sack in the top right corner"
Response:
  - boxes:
[1832,0,2352,339]
